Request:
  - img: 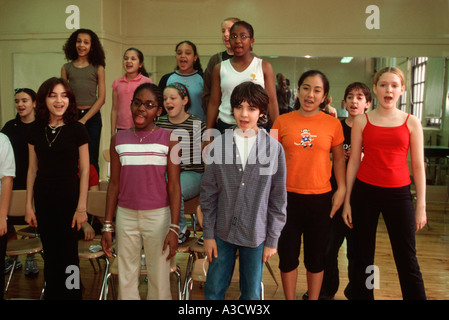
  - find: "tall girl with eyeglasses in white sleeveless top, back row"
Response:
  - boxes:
[206,21,279,133]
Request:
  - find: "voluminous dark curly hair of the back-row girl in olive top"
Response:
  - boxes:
[62,29,106,67]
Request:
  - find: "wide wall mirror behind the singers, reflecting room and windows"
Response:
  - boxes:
[145,56,447,129]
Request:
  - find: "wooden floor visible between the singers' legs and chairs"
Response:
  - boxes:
[4,195,449,300]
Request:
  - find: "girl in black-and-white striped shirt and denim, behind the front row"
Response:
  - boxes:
[156,82,206,244]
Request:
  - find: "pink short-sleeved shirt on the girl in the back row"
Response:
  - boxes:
[112,73,153,129]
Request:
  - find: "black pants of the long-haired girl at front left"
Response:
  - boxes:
[34,176,81,300]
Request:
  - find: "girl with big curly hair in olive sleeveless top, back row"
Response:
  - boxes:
[61,29,106,174]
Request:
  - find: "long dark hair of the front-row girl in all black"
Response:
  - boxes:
[36,77,78,125]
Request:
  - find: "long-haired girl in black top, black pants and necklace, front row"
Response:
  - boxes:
[25,78,89,300]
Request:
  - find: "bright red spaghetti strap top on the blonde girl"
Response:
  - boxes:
[357,114,411,188]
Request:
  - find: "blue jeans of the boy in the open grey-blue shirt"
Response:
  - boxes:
[204,238,264,300]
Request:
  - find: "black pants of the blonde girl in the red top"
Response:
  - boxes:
[351,180,426,300]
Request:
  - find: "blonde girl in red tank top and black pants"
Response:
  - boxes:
[342,67,427,299]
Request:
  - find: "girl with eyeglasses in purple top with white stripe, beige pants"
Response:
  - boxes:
[101,83,181,300]
